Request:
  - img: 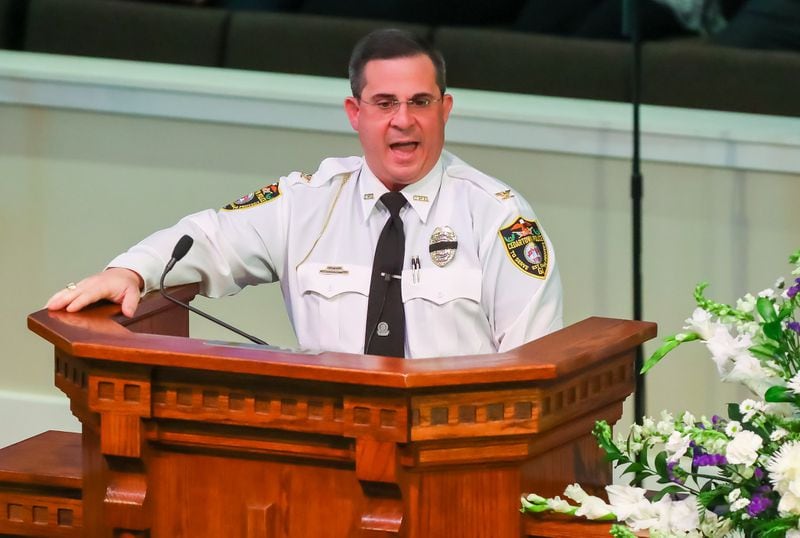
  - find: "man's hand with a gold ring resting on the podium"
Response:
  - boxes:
[46,267,144,317]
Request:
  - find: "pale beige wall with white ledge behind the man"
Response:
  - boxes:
[0,50,800,446]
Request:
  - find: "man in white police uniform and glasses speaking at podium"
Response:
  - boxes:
[47,30,562,358]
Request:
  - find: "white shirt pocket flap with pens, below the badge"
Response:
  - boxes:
[403,267,481,305]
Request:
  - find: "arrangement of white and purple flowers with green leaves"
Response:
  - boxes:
[522,250,800,538]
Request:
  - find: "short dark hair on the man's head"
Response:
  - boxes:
[348,28,447,98]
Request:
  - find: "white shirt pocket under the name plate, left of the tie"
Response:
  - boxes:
[297,263,372,353]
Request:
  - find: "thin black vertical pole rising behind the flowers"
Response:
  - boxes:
[623,0,647,423]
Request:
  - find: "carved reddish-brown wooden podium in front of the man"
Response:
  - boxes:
[28,286,656,538]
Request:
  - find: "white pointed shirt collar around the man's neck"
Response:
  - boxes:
[358,158,443,223]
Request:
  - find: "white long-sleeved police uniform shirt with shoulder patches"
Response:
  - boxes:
[109,152,562,358]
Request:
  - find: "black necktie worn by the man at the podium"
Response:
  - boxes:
[364,192,406,357]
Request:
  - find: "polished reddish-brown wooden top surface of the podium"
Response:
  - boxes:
[28,286,656,389]
